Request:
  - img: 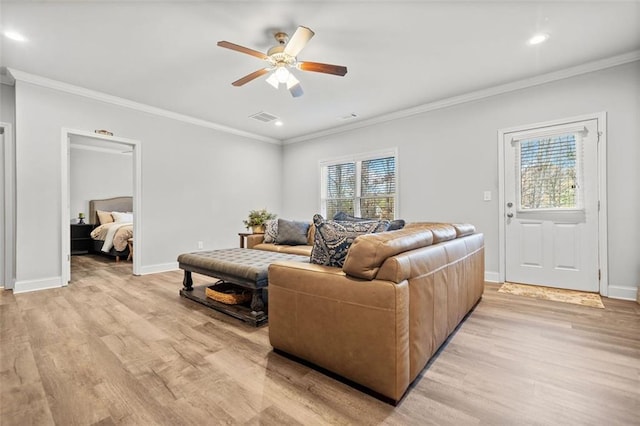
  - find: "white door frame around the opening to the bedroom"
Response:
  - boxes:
[60,127,143,286]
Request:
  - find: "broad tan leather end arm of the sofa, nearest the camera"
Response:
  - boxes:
[269,262,410,401]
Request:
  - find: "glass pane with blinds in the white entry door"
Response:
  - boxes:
[516,134,582,211]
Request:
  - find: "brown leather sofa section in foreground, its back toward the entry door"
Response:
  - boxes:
[269,223,484,403]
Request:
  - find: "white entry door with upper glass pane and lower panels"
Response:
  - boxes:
[503,119,599,292]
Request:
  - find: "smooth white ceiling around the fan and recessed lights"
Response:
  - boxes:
[0,0,640,141]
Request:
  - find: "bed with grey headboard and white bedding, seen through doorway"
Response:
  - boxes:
[89,197,133,262]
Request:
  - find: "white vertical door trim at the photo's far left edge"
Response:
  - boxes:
[0,122,16,290]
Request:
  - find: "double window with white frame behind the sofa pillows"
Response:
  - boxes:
[320,152,397,220]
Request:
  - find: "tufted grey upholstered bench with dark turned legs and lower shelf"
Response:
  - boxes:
[178,248,309,325]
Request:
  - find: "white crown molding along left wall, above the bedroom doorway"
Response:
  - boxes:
[3,68,281,145]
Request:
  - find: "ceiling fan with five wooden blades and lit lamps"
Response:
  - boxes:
[218,26,347,98]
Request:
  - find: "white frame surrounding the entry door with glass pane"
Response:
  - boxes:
[498,111,609,296]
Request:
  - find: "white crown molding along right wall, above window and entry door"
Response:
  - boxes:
[282,50,640,145]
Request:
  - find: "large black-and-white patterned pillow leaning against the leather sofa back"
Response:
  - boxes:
[311,214,389,268]
